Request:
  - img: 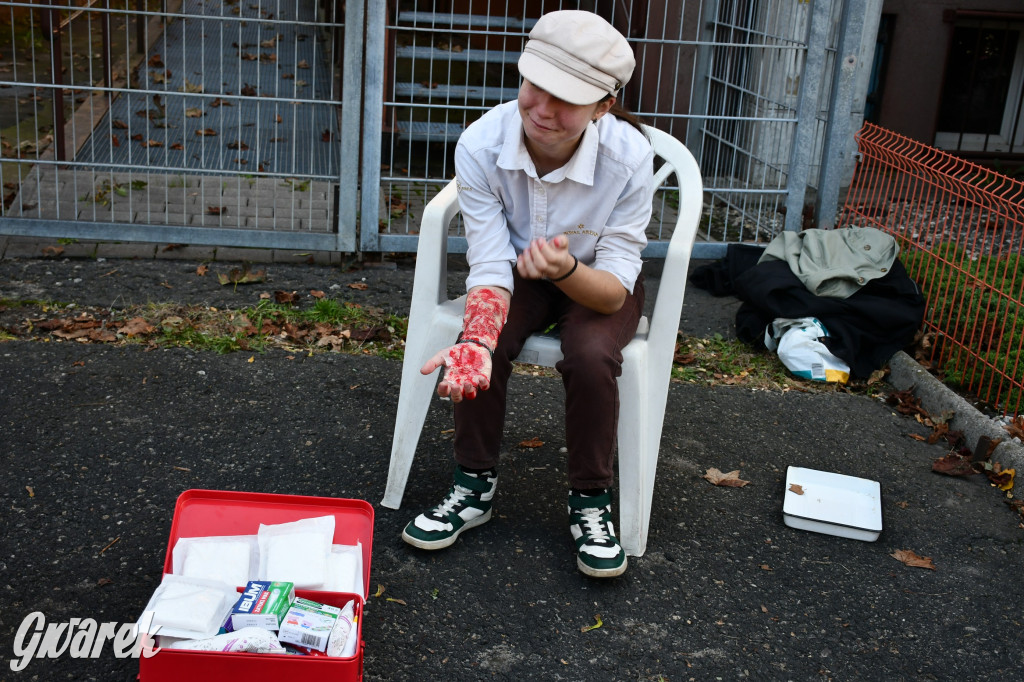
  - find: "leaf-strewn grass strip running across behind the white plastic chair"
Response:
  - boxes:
[0,298,880,391]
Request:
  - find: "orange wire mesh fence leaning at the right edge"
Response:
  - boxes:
[837,123,1024,415]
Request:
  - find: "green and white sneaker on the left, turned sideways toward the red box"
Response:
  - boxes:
[401,465,498,550]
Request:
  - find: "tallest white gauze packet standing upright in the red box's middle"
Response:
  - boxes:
[257,515,335,590]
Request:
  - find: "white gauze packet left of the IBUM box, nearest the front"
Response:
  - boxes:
[138,573,239,639]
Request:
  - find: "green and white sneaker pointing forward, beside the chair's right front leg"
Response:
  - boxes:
[569,488,626,578]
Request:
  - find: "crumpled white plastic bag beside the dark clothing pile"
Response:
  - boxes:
[765,317,850,384]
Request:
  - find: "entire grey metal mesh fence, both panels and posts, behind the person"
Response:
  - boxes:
[0,0,871,258]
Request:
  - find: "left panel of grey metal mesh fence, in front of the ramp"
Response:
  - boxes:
[0,0,352,247]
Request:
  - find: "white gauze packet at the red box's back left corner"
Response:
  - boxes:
[172,536,259,587]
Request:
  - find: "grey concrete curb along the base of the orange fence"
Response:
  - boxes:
[889,350,1024,475]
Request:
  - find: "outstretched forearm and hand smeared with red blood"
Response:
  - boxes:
[420,287,511,402]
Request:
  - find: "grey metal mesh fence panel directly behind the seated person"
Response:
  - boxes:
[372,0,842,257]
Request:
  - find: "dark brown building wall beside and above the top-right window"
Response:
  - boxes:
[879,0,1024,144]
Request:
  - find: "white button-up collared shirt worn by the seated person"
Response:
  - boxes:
[455,101,654,292]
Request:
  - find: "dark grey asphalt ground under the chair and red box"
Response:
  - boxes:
[0,246,1024,681]
